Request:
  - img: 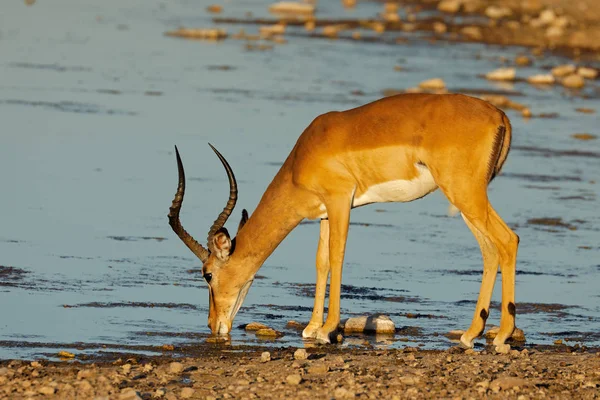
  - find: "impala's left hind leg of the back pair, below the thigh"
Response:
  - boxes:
[460,214,500,348]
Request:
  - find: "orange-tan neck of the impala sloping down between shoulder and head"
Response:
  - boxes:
[232,167,304,275]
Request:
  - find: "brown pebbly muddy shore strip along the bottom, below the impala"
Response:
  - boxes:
[0,344,600,399]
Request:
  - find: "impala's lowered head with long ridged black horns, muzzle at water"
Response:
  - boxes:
[169,144,254,334]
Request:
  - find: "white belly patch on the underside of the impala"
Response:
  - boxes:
[352,165,438,207]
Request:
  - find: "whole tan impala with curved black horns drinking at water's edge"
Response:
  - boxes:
[169,94,519,350]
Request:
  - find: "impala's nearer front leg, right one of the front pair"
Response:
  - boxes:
[317,195,352,343]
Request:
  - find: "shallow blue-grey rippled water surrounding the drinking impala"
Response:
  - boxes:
[0,0,600,358]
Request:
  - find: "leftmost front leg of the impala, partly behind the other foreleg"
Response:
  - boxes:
[302,219,329,338]
